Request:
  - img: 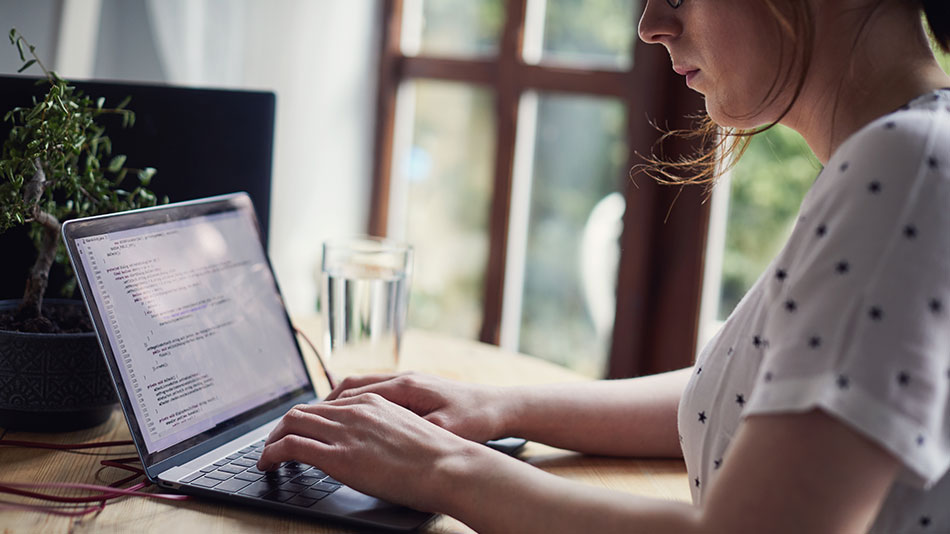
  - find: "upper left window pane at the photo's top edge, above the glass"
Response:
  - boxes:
[402,0,505,57]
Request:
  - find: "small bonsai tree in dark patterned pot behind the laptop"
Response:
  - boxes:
[0,29,167,430]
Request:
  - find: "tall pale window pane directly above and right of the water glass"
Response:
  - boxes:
[399,81,495,338]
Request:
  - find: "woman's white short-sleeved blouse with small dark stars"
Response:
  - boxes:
[678,89,950,534]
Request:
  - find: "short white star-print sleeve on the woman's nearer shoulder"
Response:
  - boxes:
[743,110,950,488]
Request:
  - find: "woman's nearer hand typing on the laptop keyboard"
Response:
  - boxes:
[257,393,494,512]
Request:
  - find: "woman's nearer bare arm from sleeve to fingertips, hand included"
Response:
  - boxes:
[258,402,899,534]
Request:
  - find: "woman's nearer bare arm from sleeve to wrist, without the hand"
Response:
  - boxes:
[439,411,899,534]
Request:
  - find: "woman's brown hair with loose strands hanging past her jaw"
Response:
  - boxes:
[644,0,950,191]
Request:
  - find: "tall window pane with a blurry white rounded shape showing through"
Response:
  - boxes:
[519,94,627,376]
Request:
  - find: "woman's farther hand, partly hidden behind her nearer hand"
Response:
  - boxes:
[326,372,512,442]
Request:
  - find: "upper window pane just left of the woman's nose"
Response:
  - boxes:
[537,0,640,69]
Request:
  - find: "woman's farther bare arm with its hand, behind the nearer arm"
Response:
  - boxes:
[327,368,692,457]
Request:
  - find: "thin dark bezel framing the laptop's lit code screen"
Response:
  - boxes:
[62,192,317,481]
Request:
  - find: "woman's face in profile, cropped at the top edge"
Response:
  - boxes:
[639,0,794,128]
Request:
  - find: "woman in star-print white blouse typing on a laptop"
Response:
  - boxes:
[259,0,950,533]
